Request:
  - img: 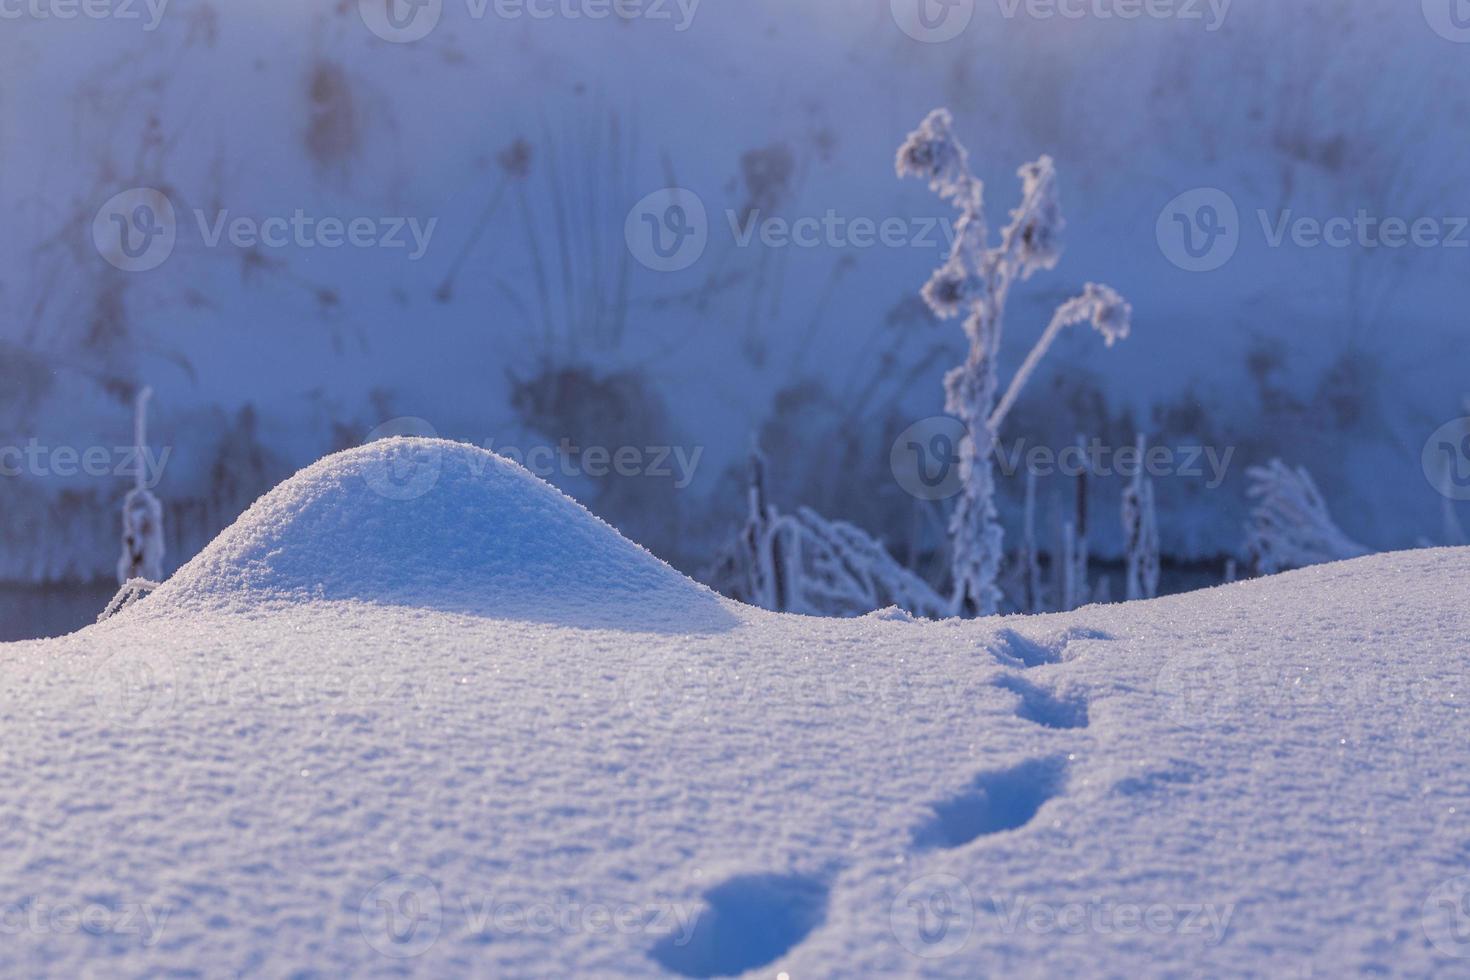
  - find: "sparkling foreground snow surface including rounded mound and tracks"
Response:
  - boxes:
[0,441,1470,977]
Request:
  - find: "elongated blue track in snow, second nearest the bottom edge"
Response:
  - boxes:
[914,757,1067,848]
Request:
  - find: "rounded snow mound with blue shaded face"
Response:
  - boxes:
[146,438,734,632]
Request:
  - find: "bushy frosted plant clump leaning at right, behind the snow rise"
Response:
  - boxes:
[1245,460,1370,574]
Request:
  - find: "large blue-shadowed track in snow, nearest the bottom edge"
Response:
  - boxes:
[648,874,829,977]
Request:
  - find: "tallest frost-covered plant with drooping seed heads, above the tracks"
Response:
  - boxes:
[897,109,1132,616]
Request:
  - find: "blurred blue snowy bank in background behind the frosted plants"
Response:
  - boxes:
[0,0,1470,599]
